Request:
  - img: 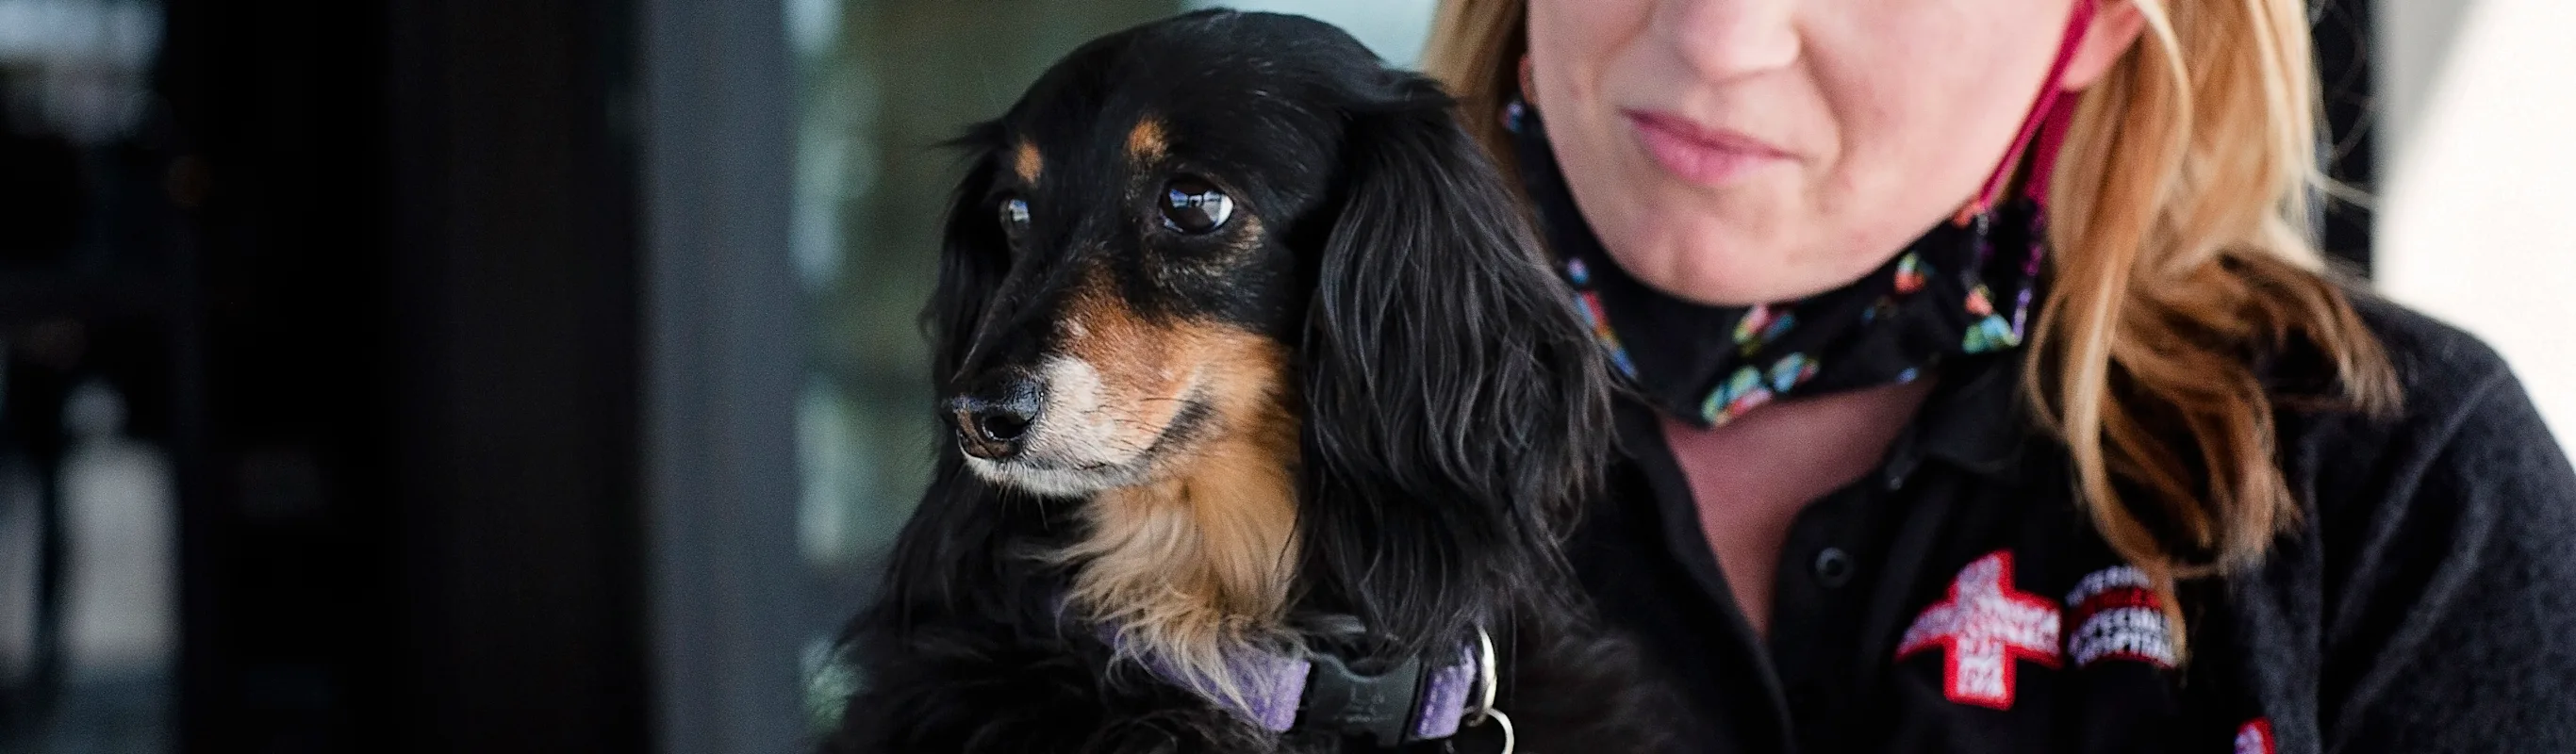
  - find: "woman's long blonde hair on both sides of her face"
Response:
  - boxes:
[1425,0,2398,617]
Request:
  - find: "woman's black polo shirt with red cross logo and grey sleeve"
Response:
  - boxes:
[1572,293,2576,751]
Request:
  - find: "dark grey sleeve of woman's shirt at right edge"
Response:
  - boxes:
[2319,362,2576,751]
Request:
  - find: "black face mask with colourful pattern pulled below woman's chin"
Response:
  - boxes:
[1504,100,2048,427]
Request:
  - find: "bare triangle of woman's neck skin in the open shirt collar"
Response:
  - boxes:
[1664,378,1932,635]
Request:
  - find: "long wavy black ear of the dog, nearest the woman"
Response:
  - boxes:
[1301,72,1610,648]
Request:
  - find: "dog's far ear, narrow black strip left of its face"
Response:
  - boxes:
[922,121,1010,384]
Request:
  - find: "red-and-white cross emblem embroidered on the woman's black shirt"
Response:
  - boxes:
[1896,550,2058,711]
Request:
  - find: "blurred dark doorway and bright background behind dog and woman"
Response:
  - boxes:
[0,0,2576,754]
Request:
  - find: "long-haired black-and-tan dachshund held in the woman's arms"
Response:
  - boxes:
[824,13,1648,754]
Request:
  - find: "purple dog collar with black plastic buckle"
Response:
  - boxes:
[1105,622,1496,746]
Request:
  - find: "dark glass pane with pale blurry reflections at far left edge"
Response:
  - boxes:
[0,0,178,751]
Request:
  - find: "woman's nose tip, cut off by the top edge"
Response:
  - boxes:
[1654,0,1801,82]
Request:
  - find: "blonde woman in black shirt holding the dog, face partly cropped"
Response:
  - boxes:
[1429,0,2576,751]
